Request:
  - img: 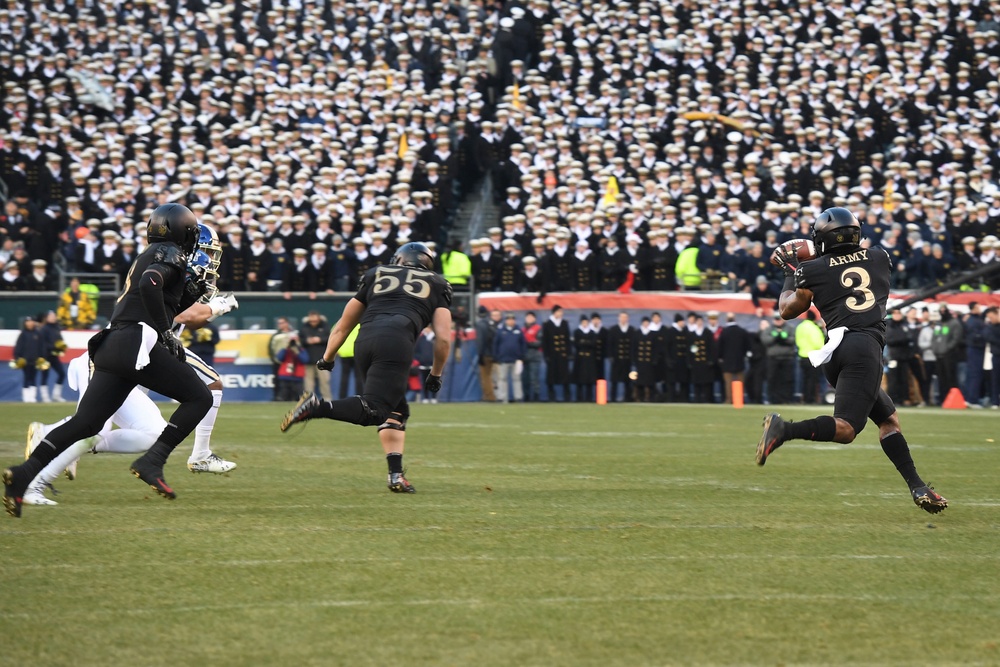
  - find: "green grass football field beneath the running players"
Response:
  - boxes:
[0,404,1000,667]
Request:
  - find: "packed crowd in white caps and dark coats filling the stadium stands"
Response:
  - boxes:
[0,0,1000,297]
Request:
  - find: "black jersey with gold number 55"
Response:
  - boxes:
[354,265,451,340]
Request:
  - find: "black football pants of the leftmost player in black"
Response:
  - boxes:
[31,325,212,466]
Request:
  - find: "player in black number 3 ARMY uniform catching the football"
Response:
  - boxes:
[757,207,948,514]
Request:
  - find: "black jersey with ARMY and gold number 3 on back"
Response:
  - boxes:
[795,246,892,345]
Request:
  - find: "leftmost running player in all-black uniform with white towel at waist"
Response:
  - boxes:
[3,204,212,516]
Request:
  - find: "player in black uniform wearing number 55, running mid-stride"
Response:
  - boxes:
[281,243,451,493]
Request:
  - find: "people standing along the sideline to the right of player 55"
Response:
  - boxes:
[473,302,1000,409]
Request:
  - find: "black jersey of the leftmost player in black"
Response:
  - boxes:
[111,242,190,331]
